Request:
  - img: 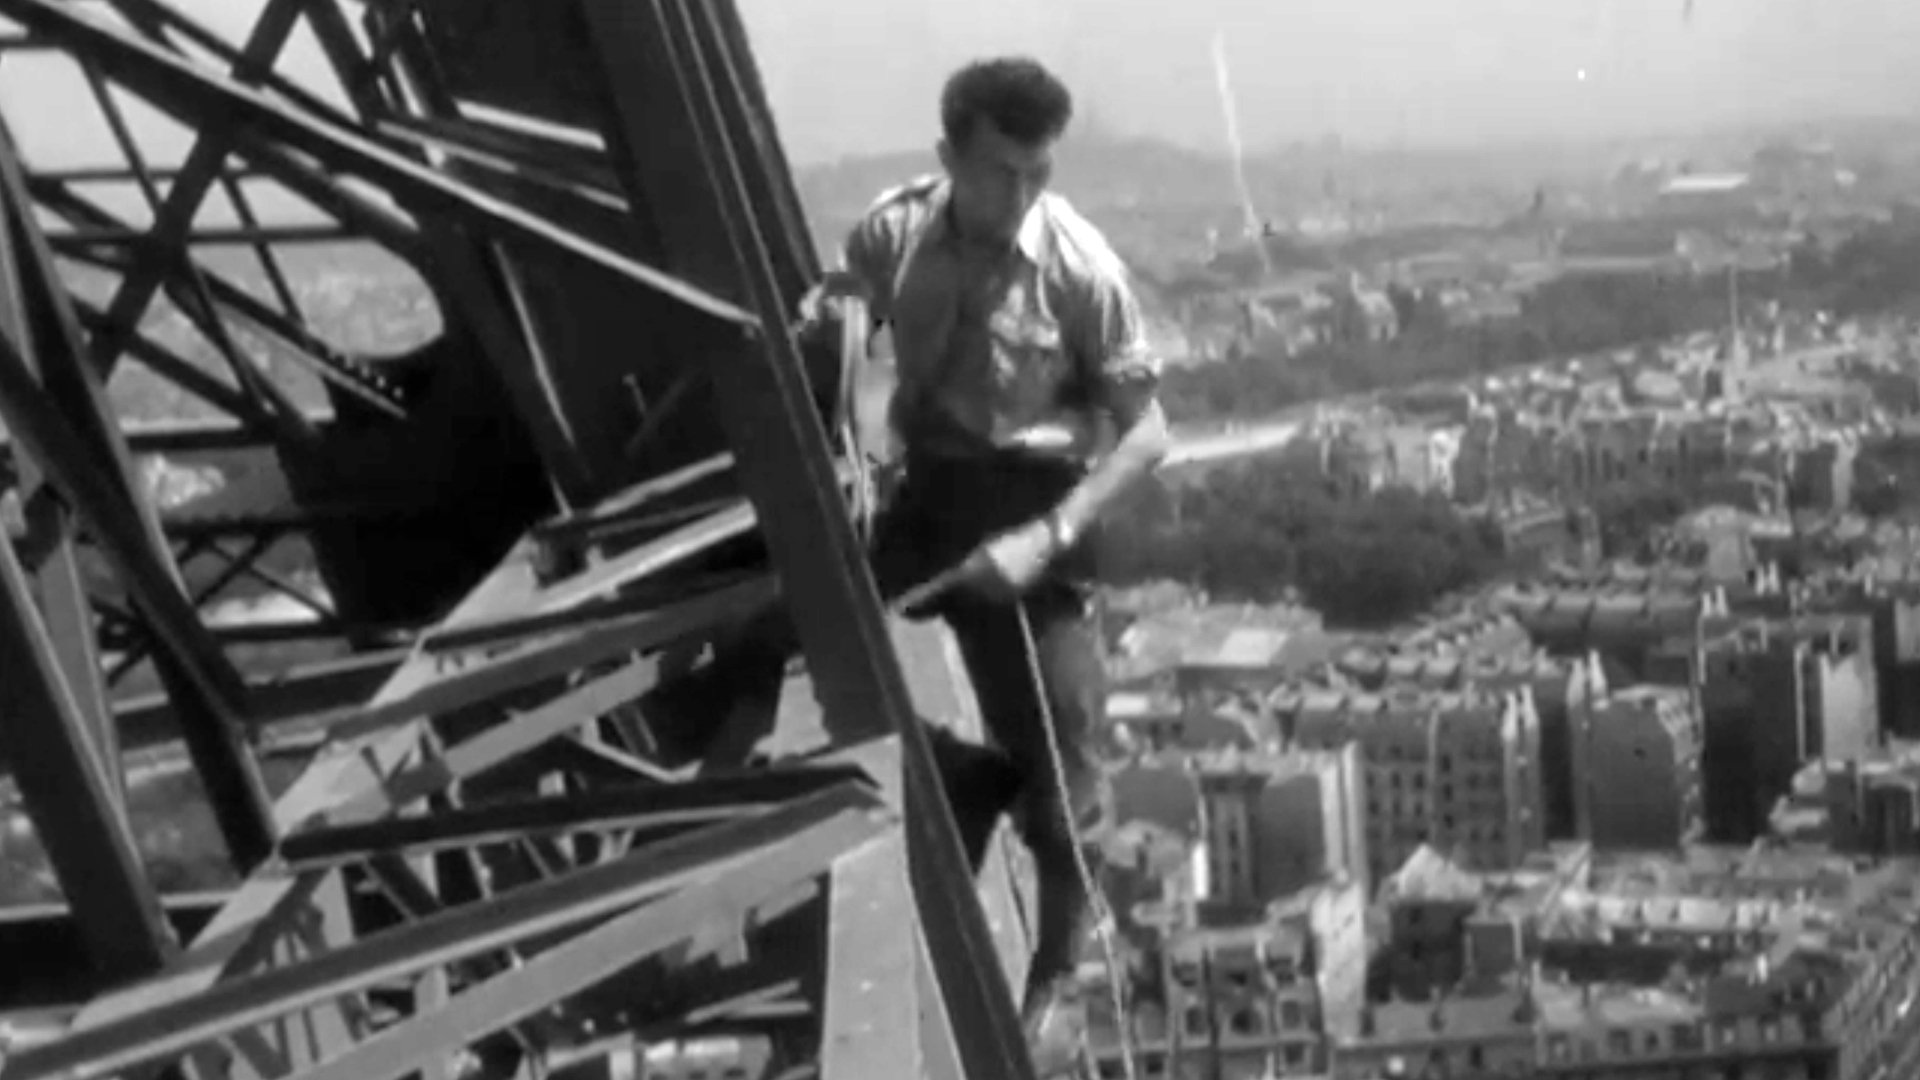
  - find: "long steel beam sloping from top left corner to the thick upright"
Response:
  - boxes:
[0,0,758,329]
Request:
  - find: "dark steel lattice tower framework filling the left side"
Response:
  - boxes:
[0,0,1031,1080]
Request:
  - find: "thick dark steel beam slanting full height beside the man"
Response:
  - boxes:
[576,0,1033,1080]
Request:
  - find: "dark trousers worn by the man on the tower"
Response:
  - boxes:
[874,447,1106,997]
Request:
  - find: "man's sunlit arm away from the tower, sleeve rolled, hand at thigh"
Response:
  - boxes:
[1056,256,1173,536]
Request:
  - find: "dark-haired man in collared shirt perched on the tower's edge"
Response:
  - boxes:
[808,58,1167,1057]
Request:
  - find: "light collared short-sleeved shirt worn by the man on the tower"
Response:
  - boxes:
[845,177,1160,452]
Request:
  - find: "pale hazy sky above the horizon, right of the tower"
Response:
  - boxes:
[741,0,1920,161]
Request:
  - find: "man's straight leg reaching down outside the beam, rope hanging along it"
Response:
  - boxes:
[950,586,1106,1020]
